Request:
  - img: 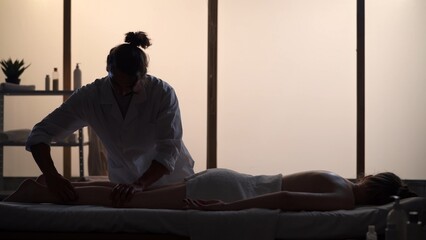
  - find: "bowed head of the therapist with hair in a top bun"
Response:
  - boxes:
[107,32,151,78]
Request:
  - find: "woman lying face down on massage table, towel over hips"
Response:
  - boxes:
[4,169,416,211]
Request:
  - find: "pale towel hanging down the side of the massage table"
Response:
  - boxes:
[189,209,280,240]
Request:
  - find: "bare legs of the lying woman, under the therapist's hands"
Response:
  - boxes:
[3,179,186,209]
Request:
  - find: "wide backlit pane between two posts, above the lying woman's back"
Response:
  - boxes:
[218,0,356,177]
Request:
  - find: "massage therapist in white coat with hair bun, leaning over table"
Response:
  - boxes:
[26,32,194,202]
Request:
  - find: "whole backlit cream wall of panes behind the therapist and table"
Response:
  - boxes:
[0,0,426,179]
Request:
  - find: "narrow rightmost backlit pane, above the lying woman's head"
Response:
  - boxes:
[366,0,426,179]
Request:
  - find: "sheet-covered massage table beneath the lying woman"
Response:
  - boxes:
[0,197,426,240]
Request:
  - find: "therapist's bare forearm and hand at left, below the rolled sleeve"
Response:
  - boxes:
[30,143,77,202]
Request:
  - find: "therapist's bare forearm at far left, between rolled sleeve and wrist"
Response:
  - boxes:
[30,143,58,175]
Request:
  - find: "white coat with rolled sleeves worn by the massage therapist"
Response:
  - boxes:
[26,75,194,185]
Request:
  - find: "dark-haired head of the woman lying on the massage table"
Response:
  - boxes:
[357,172,417,205]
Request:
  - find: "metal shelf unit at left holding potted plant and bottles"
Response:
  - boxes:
[0,90,89,189]
